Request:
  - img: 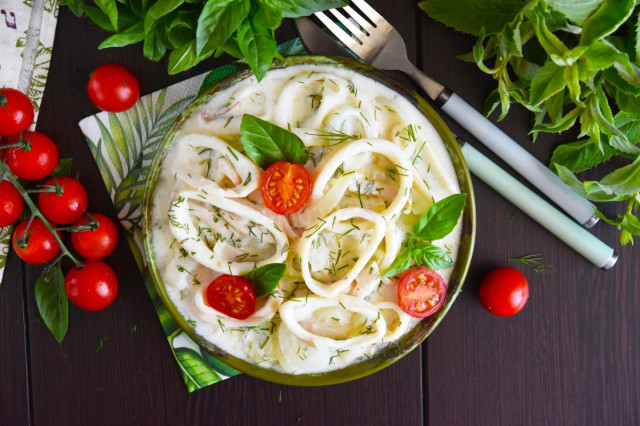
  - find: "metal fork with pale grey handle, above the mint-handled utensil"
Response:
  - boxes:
[315,0,598,228]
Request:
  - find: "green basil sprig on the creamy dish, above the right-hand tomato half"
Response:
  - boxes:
[382,194,467,278]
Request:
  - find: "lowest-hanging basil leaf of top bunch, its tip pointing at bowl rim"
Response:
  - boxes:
[236,12,277,81]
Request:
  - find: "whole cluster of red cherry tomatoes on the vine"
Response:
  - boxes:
[0,88,118,311]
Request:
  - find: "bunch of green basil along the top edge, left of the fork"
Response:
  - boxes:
[62,0,349,80]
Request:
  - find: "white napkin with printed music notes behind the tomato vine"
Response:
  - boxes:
[0,0,59,281]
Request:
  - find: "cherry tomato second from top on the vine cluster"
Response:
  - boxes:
[7,132,58,180]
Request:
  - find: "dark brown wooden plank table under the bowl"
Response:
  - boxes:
[0,0,640,426]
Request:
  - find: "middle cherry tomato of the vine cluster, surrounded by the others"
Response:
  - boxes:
[38,177,88,225]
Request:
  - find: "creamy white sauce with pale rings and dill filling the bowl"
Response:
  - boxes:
[152,65,461,374]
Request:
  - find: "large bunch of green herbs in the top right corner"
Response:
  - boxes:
[419,0,640,245]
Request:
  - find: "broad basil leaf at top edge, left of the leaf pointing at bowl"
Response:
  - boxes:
[196,0,250,55]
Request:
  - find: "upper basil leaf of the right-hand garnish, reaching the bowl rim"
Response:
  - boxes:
[413,194,467,241]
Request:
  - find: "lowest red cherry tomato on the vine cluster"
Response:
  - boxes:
[64,260,118,311]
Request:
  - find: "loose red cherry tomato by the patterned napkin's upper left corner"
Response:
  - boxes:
[87,64,140,112]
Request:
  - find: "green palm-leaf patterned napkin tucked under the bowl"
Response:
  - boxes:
[79,39,305,392]
